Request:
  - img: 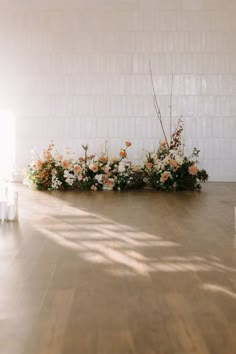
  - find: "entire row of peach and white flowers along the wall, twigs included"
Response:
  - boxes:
[25,66,208,191]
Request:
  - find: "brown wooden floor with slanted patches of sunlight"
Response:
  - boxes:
[0,183,236,354]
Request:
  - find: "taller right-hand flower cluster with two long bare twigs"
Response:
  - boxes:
[142,66,208,191]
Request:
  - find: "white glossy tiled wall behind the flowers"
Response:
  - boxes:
[0,0,236,181]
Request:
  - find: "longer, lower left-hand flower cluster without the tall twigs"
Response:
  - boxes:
[24,141,144,191]
